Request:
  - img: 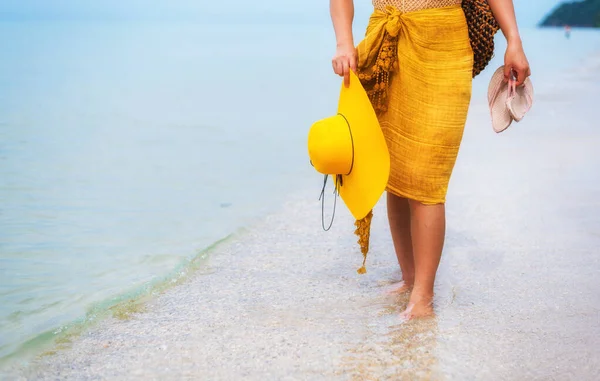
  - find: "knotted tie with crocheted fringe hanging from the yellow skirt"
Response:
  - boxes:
[356,6,404,115]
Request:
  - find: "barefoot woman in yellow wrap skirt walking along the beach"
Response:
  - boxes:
[330,0,531,318]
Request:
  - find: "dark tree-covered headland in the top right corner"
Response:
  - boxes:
[534,0,600,28]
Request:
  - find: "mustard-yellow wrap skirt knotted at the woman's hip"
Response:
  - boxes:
[357,5,473,204]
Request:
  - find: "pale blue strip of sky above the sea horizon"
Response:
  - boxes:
[0,0,562,26]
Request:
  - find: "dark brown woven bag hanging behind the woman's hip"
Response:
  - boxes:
[462,0,500,77]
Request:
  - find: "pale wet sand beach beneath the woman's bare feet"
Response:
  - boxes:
[5,59,600,380]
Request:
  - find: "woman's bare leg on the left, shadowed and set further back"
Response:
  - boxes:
[387,192,415,293]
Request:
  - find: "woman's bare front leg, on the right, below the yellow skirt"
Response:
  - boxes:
[404,200,446,318]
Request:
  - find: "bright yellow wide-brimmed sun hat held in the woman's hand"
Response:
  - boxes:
[308,71,390,220]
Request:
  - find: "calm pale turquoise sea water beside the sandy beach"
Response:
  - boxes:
[0,12,600,358]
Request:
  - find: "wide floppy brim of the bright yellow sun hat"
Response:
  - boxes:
[338,71,390,220]
